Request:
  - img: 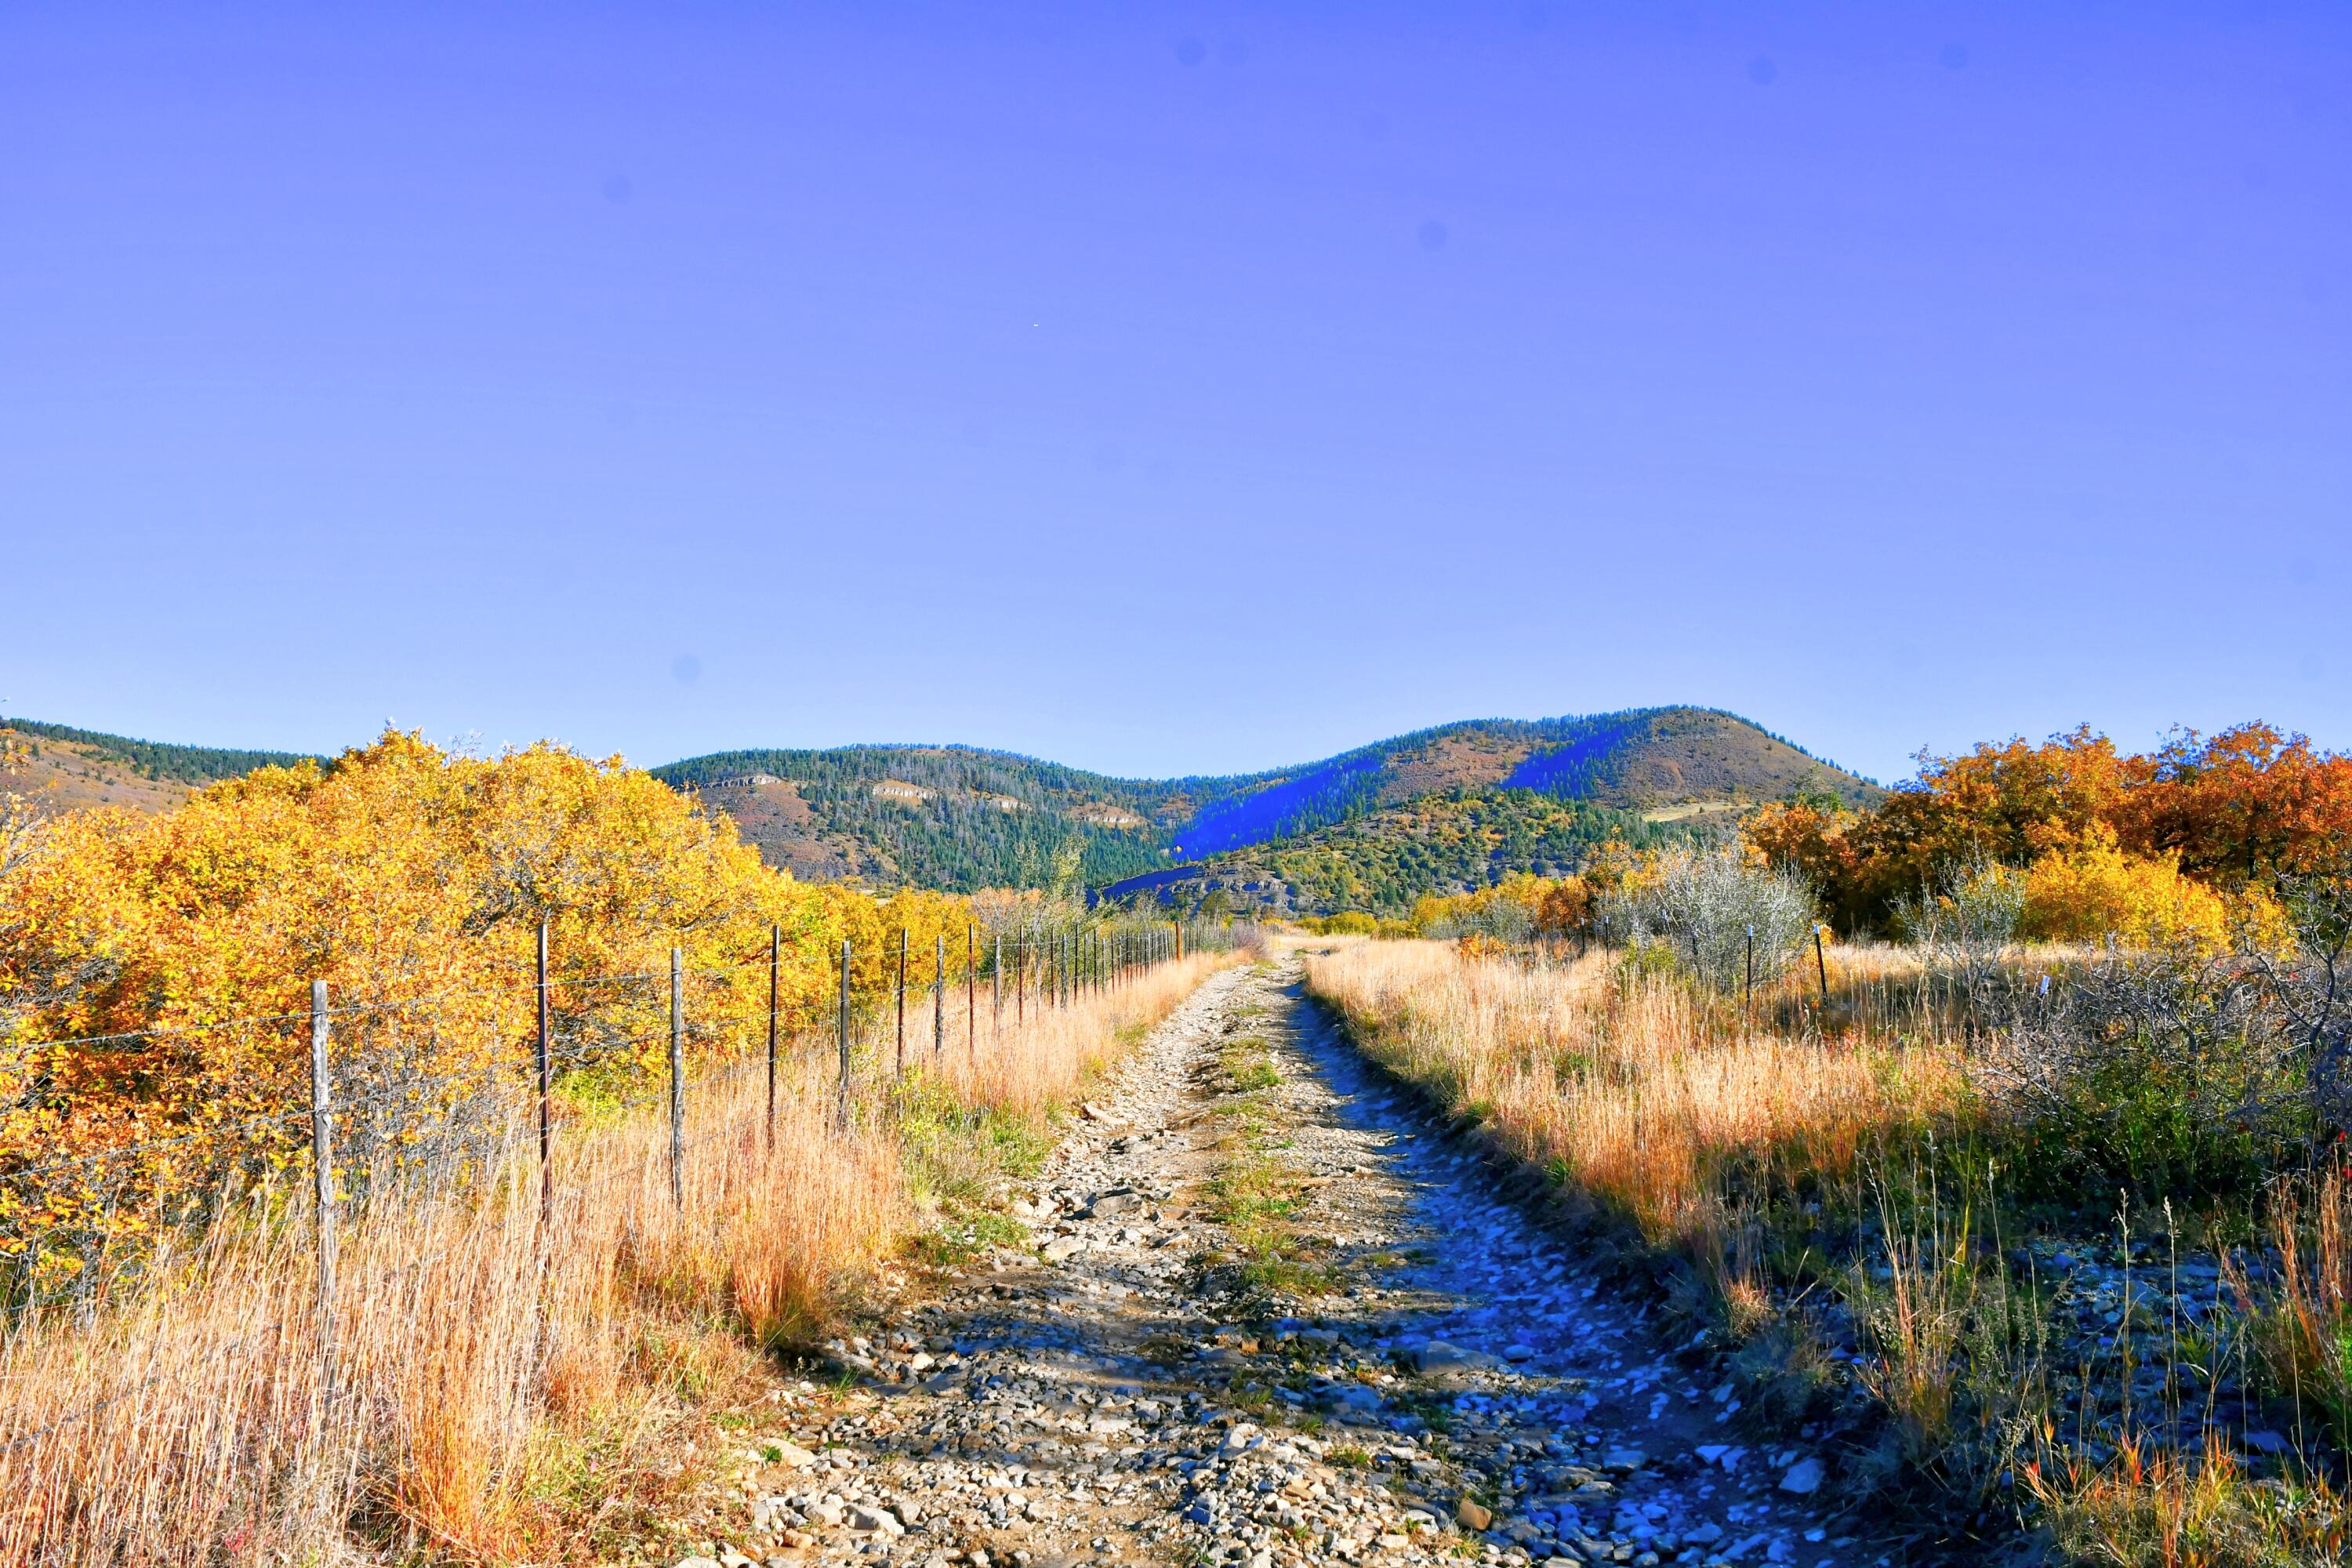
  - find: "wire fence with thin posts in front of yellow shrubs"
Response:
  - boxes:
[0,921,1249,1455]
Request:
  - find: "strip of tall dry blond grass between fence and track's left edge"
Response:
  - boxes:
[0,956,1221,1566]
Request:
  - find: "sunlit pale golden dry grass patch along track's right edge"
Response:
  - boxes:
[1308,942,1966,1312]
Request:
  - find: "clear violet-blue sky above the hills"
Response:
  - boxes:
[0,0,2352,779]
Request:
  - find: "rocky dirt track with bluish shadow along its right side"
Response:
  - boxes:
[689,959,1886,1568]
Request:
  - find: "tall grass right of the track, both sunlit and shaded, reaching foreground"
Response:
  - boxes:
[1308,942,2352,1566]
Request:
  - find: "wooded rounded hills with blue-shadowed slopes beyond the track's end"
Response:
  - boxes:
[654,708,1879,909]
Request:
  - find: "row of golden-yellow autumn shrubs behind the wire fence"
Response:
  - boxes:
[0,731,1011,1293]
